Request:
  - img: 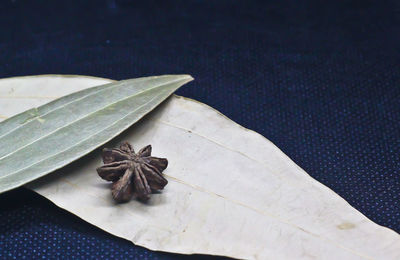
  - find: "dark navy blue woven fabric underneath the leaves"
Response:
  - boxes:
[0,0,400,259]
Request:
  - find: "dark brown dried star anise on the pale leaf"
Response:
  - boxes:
[97,142,168,202]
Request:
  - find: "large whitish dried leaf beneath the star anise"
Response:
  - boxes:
[0,76,400,259]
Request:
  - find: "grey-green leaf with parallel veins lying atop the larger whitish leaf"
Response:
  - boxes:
[0,75,192,193]
